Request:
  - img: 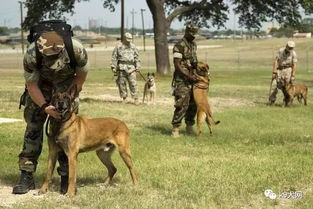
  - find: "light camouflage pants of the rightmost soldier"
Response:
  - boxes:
[269,68,292,103]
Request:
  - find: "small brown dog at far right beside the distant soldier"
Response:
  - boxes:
[284,84,308,106]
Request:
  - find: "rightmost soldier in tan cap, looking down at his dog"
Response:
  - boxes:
[269,41,297,105]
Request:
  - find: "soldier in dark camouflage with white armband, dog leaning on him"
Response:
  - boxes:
[172,24,198,137]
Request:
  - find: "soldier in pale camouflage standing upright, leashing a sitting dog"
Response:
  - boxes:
[111,33,140,104]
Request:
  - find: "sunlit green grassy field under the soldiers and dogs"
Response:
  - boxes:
[0,39,313,209]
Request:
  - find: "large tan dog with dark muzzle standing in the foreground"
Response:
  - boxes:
[39,86,137,196]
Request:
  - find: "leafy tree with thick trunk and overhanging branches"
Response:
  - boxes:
[24,0,313,74]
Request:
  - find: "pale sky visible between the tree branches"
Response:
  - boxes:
[0,0,236,29]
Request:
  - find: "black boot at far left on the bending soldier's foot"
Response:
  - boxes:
[12,171,35,194]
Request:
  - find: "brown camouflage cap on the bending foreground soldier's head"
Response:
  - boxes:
[37,31,65,56]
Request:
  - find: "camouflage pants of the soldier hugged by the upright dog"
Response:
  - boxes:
[172,80,197,127]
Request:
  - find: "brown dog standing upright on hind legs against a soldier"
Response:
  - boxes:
[193,62,220,135]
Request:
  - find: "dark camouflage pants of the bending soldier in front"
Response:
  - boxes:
[19,84,78,176]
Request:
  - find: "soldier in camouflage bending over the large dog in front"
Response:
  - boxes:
[13,31,88,194]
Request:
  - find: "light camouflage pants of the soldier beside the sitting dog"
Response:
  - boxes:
[116,70,138,99]
